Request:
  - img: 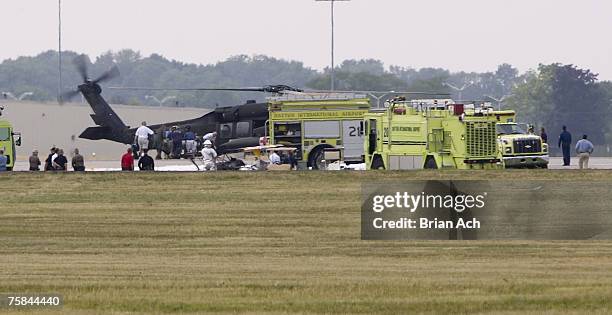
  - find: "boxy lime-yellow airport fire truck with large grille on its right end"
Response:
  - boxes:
[364,97,502,170]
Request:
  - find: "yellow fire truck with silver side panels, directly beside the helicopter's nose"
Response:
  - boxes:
[267,93,370,169]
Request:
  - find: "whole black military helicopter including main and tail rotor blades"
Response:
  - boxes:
[60,56,301,158]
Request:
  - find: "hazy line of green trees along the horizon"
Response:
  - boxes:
[0,49,612,143]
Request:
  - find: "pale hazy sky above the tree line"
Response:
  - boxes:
[0,0,612,80]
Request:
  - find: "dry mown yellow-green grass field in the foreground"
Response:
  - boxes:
[0,170,612,314]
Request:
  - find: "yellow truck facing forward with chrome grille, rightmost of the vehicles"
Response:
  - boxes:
[494,110,549,168]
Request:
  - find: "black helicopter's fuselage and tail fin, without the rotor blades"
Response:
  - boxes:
[78,82,268,154]
